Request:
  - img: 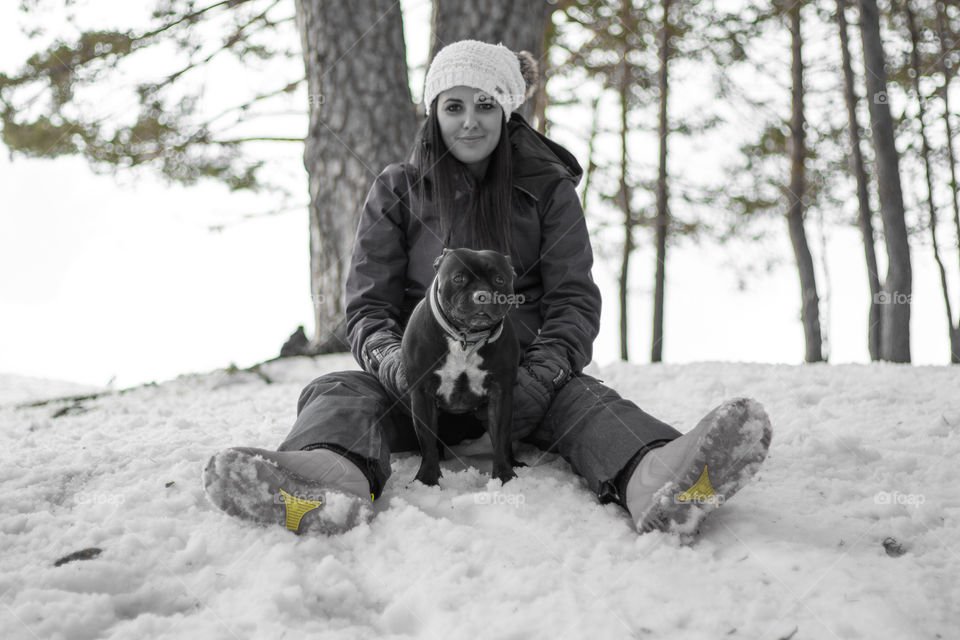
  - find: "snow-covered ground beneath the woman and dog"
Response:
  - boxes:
[0,356,960,640]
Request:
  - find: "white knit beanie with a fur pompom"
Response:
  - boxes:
[423,40,537,120]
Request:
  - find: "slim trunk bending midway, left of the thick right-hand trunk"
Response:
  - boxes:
[787,2,823,362]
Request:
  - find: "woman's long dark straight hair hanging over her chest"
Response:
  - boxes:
[413,98,514,254]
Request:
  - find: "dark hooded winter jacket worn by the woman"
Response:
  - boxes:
[346,114,600,387]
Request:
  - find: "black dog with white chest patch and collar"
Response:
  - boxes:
[402,249,520,485]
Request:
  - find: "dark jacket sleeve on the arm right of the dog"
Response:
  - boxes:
[525,180,601,388]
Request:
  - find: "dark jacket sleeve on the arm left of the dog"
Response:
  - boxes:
[346,164,408,373]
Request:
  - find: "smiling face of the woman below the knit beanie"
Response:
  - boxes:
[437,86,503,175]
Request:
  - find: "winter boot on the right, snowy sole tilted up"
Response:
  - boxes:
[626,398,771,536]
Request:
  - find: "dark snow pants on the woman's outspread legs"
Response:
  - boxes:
[280,371,680,503]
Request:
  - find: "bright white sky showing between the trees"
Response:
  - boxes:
[0,1,955,387]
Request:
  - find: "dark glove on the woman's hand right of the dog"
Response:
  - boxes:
[513,349,570,438]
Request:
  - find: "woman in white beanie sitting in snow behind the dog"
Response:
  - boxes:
[204,40,770,533]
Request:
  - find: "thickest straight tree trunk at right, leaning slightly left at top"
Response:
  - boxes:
[857,0,913,362]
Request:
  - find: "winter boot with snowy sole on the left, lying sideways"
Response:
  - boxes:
[203,447,373,534]
